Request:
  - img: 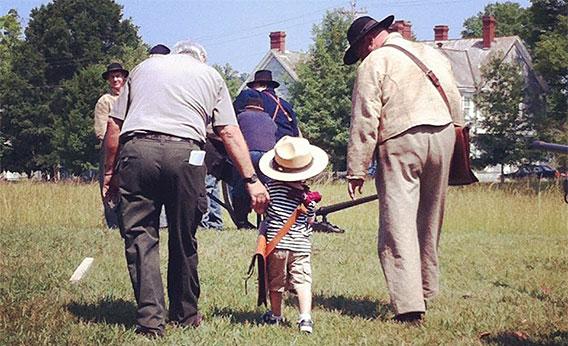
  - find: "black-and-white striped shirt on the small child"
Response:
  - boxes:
[264,181,315,253]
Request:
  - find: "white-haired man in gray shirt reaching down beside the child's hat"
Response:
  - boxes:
[103,41,269,336]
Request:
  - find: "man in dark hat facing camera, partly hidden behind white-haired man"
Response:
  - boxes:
[94,63,128,228]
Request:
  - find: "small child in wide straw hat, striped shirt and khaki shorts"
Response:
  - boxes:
[259,136,328,333]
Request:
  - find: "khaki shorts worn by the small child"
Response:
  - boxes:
[267,249,312,292]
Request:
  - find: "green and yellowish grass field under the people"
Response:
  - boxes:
[0,182,568,345]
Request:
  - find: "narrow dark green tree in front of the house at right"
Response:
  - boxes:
[474,54,533,178]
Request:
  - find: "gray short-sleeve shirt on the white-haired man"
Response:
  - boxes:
[111,54,237,142]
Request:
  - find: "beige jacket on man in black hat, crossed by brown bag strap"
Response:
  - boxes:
[347,33,463,177]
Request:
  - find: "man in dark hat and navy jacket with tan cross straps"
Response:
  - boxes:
[233,70,300,141]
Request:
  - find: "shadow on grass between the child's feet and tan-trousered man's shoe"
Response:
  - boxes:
[313,294,391,320]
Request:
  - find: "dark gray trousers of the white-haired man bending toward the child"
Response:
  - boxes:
[118,138,207,331]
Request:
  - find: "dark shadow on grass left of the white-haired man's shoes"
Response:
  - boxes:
[67,299,136,328]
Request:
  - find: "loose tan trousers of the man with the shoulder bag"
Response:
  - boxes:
[376,124,455,314]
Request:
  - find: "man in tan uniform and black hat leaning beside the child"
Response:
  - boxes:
[344,16,461,323]
